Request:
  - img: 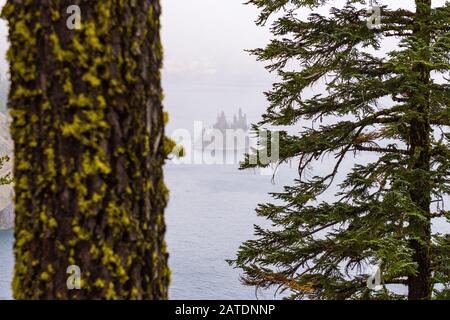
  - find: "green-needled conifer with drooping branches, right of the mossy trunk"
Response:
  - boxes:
[230,0,450,300]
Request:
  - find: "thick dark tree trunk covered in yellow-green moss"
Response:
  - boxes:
[2,0,169,299]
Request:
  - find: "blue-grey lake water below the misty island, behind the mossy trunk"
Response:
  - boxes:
[0,164,291,299]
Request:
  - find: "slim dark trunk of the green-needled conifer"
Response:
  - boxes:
[408,0,431,300]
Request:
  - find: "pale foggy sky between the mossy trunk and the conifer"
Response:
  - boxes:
[162,0,270,84]
